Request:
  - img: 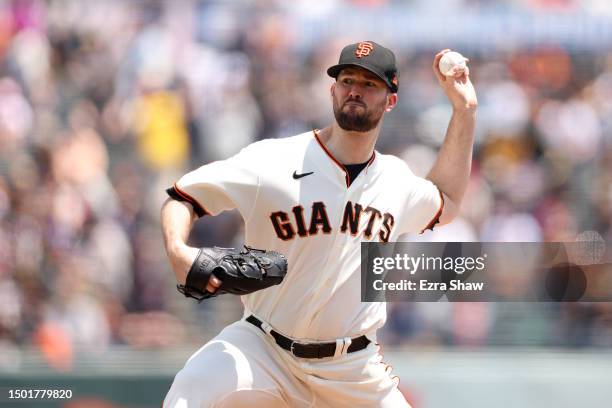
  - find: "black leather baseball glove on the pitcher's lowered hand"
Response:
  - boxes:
[177,245,287,302]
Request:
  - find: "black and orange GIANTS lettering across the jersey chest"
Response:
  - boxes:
[270,201,395,242]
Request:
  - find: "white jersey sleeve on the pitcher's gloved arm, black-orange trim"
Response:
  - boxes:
[167,147,259,219]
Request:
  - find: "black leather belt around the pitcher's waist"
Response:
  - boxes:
[246,315,370,358]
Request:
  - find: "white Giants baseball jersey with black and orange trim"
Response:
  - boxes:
[174,131,443,341]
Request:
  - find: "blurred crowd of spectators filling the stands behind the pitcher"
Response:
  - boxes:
[0,0,612,369]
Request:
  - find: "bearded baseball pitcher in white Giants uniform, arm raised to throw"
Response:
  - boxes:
[161,41,477,408]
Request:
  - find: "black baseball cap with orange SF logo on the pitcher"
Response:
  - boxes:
[327,41,399,93]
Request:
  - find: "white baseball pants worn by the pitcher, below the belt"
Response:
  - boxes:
[163,320,410,408]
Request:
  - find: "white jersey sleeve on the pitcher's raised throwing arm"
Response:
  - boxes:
[400,161,444,234]
